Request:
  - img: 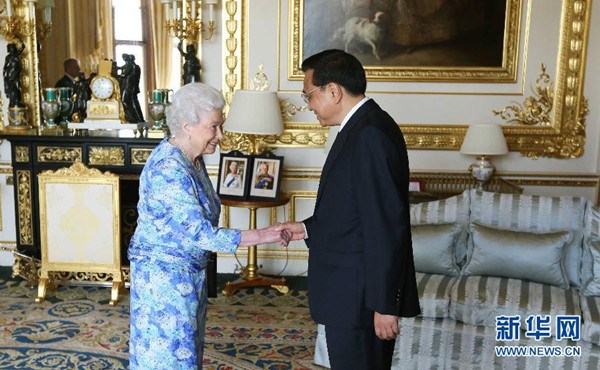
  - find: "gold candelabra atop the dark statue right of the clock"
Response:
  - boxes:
[161,0,218,44]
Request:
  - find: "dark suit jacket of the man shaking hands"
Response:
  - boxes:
[304,100,420,328]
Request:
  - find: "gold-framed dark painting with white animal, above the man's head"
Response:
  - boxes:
[288,0,522,82]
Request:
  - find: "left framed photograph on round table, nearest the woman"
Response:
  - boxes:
[217,150,250,199]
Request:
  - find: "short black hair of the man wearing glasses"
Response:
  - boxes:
[302,49,367,96]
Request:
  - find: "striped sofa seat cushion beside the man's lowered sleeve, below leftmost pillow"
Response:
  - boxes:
[416,272,456,317]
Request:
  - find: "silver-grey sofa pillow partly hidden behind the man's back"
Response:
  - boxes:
[411,224,463,276]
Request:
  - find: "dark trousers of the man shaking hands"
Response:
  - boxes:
[325,326,396,370]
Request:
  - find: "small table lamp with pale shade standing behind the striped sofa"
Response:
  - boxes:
[460,124,508,190]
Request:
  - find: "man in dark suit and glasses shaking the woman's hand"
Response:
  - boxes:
[284,50,420,370]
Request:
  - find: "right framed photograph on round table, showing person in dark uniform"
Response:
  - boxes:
[250,153,283,199]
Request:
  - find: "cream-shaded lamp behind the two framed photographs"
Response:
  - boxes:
[225,90,283,155]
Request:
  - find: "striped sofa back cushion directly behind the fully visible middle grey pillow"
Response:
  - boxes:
[470,190,587,288]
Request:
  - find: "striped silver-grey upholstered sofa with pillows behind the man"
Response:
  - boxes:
[315,190,600,369]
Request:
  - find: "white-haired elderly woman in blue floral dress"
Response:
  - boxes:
[128,83,289,370]
